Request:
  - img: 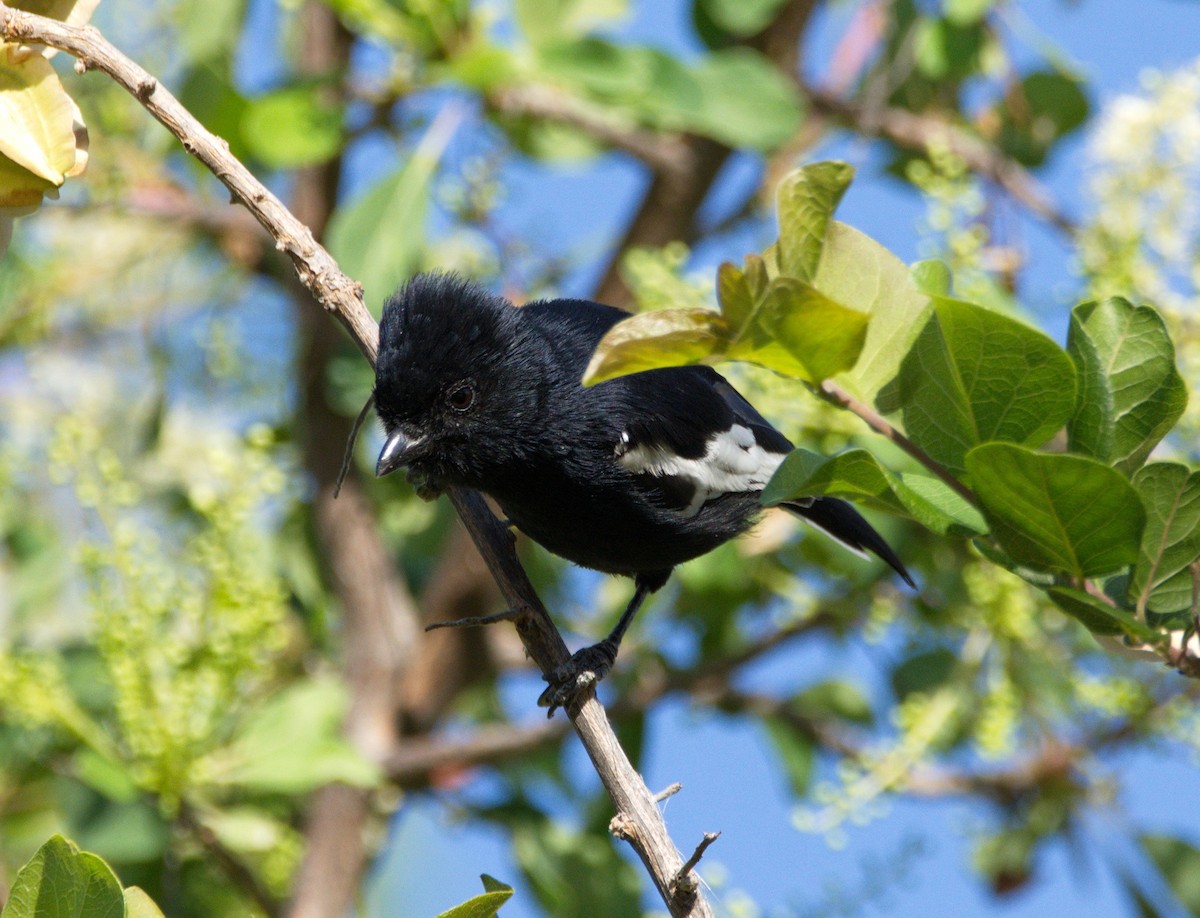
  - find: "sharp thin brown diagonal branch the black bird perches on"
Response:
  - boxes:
[0,4,712,916]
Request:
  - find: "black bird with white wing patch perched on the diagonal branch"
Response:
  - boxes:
[374,268,916,714]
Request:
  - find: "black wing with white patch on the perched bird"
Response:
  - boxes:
[613,367,792,516]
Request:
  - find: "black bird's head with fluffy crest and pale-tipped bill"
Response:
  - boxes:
[374,274,540,493]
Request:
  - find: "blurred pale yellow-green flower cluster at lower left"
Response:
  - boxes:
[0,412,290,810]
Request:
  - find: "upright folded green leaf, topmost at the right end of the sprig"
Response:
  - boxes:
[1067,296,1188,475]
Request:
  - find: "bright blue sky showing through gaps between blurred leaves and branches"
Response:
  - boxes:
[350,0,1200,918]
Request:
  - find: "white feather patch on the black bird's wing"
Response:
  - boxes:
[616,424,785,516]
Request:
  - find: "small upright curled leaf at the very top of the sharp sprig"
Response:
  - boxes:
[775,162,854,281]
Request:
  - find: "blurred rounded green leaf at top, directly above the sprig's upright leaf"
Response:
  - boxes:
[683,48,801,150]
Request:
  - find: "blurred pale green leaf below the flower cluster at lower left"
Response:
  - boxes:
[201,679,379,794]
